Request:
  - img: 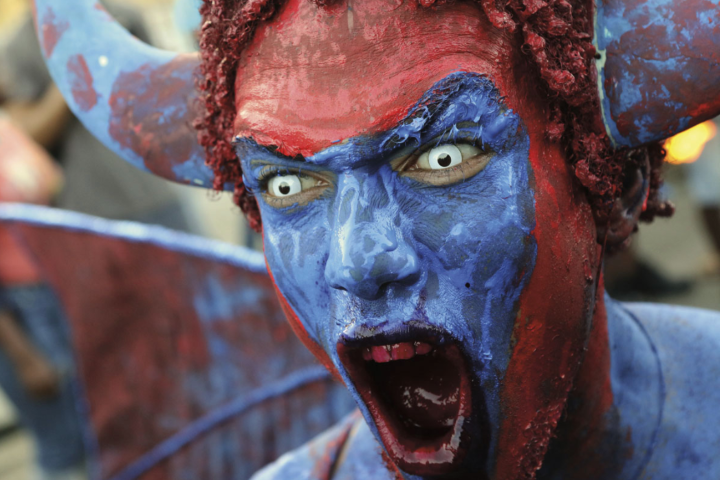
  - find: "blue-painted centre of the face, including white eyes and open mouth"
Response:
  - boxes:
[237,73,537,474]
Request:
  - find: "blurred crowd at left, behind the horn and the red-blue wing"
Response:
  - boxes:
[0,0,242,480]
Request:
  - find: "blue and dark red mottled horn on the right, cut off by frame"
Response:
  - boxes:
[595,0,720,146]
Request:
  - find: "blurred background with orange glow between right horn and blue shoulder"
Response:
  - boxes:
[605,117,720,302]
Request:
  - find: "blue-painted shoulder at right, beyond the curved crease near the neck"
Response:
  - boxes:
[625,304,720,480]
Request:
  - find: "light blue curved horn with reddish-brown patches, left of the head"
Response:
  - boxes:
[35,0,213,188]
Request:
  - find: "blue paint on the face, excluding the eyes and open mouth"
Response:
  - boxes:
[238,73,536,476]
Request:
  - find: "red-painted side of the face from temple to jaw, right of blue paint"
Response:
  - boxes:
[498,132,598,476]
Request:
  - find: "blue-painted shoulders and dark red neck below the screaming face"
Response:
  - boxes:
[253,296,720,480]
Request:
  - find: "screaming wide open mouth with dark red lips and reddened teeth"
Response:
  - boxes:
[338,335,472,475]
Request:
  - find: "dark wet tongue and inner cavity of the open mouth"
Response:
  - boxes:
[371,347,460,435]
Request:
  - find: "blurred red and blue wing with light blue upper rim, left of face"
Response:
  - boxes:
[0,204,354,480]
